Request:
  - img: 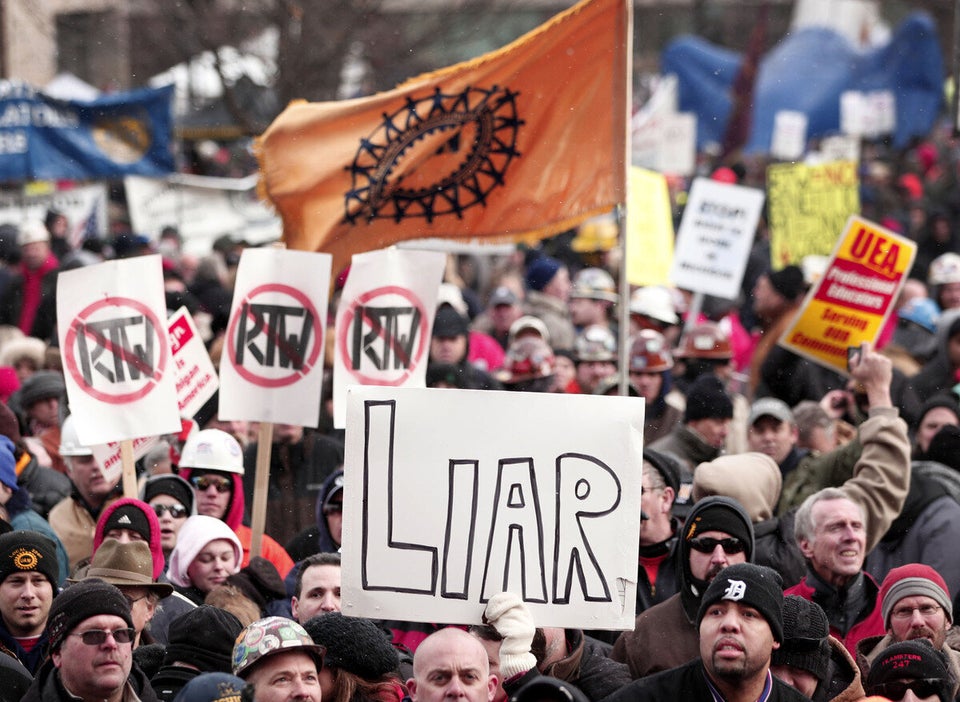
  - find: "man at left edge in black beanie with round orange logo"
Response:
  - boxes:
[0,531,59,675]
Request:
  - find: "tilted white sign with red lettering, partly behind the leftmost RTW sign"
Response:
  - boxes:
[171,307,220,418]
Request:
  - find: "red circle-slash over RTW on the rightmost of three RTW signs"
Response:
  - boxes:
[337,285,429,387]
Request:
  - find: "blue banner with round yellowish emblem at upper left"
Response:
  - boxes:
[0,82,174,181]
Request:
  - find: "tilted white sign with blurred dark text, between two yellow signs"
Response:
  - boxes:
[670,178,764,300]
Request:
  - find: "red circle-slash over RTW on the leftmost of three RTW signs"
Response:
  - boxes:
[64,297,169,405]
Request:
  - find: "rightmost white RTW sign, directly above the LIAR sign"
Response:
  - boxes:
[333,248,447,429]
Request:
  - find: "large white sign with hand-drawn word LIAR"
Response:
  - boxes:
[342,385,644,629]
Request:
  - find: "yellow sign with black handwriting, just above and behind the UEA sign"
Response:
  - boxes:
[767,161,860,270]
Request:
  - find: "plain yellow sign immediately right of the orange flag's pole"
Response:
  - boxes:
[626,166,674,285]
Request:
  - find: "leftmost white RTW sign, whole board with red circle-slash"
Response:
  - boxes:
[57,256,180,446]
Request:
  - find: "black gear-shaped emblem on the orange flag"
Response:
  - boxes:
[344,86,523,224]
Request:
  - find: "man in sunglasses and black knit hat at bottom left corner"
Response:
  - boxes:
[23,579,157,702]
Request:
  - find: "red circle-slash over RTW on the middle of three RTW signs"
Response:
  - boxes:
[227,283,323,388]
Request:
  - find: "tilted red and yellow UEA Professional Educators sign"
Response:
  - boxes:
[780,217,917,374]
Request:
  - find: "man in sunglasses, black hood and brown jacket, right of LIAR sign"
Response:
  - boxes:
[610,497,754,678]
